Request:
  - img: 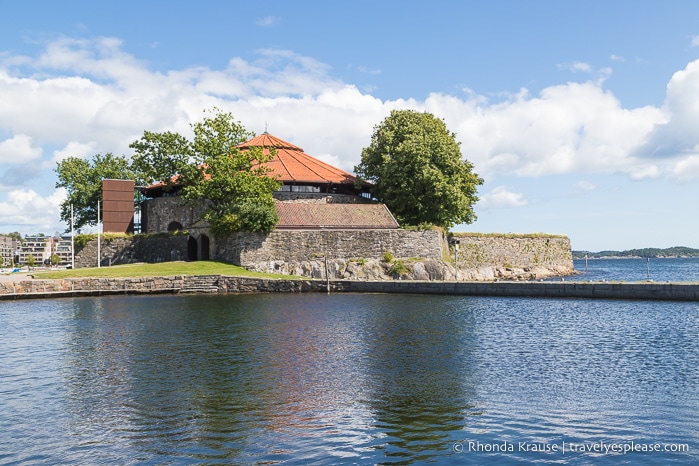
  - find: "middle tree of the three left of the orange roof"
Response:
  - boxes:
[129,131,196,190]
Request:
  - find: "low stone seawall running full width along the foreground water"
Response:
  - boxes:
[0,275,699,301]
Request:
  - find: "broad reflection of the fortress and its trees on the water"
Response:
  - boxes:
[60,295,486,462]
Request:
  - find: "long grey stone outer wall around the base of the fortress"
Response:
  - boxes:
[69,230,574,281]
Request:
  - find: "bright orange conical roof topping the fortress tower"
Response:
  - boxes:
[238,132,356,185]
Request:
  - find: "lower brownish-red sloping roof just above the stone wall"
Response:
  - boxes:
[276,202,399,230]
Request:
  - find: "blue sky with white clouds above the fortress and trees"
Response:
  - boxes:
[0,0,699,251]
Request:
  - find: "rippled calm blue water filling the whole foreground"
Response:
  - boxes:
[0,294,699,465]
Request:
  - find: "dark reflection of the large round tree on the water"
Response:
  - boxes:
[363,296,477,462]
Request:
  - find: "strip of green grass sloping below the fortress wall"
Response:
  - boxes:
[33,261,302,279]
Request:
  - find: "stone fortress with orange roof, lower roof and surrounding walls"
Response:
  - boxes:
[86,132,574,280]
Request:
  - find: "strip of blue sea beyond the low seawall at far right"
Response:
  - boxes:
[566,257,699,282]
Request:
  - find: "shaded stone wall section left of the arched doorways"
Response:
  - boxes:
[75,234,188,268]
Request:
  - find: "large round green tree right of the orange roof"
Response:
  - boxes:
[354,110,483,229]
